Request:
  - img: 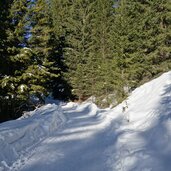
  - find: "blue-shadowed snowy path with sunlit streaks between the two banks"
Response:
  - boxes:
[13,105,120,171]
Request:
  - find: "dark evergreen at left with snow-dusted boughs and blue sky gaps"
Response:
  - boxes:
[0,0,58,119]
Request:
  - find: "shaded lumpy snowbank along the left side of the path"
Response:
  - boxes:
[0,104,66,170]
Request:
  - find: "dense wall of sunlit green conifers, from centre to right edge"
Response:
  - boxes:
[52,0,170,105]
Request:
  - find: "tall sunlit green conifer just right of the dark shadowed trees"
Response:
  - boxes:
[53,0,94,100]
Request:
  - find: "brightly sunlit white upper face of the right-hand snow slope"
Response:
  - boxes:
[123,72,171,122]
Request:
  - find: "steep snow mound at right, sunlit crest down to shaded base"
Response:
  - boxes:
[107,72,171,171]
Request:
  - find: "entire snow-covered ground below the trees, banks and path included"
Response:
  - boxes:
[0,72,171,171]
